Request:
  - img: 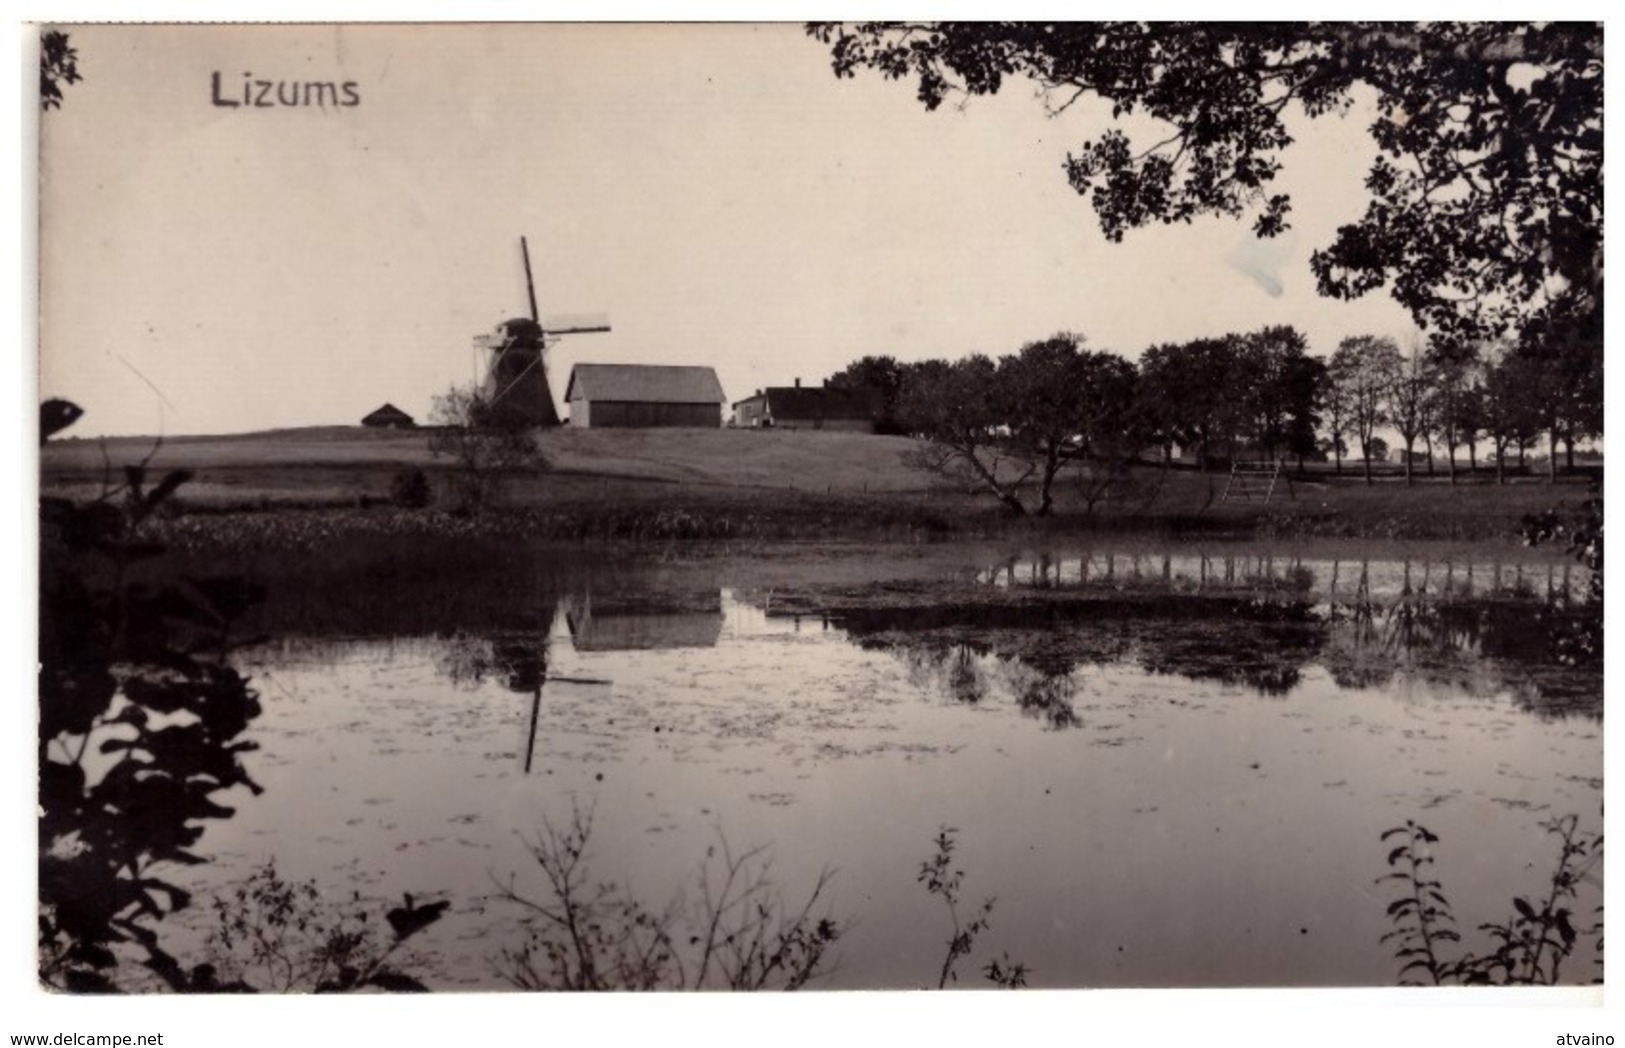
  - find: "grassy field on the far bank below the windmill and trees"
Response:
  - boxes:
[41,427,1589,541]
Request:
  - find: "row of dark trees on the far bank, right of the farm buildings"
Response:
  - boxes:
[829,327,1602,515]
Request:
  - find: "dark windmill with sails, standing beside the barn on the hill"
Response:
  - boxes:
[475,237,609,426]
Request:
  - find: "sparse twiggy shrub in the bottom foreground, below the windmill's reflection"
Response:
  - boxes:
[497,808,842,991]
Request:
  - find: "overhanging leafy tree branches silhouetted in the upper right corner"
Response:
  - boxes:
[808,23,1602,357]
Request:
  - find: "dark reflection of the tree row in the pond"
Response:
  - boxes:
[806,582,1602,726]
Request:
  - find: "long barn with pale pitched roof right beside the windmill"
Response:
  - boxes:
[564,364,728,429]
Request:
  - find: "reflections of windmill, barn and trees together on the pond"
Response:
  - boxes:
[406,571,1602,744]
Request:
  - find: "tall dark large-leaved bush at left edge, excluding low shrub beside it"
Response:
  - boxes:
[39,405,262,991]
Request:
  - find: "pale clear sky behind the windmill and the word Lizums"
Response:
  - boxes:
[28,24,1415,435]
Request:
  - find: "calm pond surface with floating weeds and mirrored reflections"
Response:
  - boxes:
[168,549,1602,990]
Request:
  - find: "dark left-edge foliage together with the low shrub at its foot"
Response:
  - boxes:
[39,401,447,993]
